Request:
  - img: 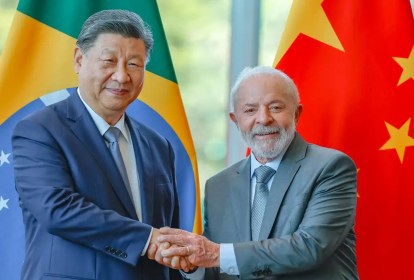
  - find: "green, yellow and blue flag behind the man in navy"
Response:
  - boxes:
[0,0,201,280]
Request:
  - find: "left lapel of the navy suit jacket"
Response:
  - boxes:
[67,89,138,219]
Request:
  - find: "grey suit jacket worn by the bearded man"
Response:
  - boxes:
[204,134,358,280]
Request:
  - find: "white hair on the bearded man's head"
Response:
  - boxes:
[230,66,300,112]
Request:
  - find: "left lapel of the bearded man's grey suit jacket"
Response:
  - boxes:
[230,157,251,242]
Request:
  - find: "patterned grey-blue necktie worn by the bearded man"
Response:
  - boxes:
[251,165,276,241]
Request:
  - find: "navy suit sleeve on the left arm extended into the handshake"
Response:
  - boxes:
[12,120,151,265]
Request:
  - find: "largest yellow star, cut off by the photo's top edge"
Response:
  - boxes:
[273,0,344,66]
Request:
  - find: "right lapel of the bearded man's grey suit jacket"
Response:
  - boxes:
[259,134,307,240]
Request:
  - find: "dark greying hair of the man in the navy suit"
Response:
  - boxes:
[76,10,154,62]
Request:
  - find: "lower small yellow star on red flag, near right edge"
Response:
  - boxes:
[380,118,414,163]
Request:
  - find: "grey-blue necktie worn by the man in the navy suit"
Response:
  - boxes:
[104,126,133,201]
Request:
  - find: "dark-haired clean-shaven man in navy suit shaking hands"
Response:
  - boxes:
[12,10,180,280]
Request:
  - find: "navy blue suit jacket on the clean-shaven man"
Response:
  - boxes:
[12,92,179,280]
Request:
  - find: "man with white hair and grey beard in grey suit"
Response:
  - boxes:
[149,67,358,280]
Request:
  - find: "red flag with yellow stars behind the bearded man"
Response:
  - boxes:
[274,0,414,280]
